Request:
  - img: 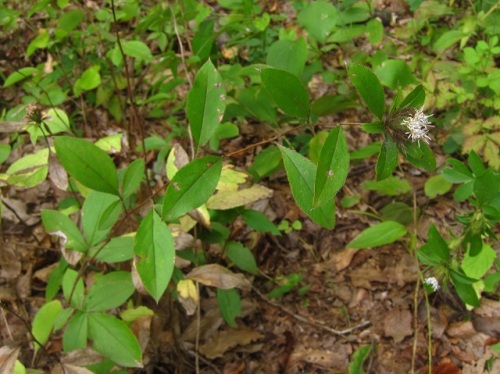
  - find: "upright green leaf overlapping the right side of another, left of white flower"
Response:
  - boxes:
[313,126,349,208]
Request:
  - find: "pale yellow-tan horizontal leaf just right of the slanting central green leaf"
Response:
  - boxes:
[207,184,273,210]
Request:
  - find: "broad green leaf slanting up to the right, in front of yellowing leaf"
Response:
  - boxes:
[162,156,222,221]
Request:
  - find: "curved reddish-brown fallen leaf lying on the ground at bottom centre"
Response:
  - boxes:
[200,327,262,359]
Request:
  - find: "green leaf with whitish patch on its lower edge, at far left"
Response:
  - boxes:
[42,209,87,253]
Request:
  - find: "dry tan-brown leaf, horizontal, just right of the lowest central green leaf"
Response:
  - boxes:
[186,264,251,290]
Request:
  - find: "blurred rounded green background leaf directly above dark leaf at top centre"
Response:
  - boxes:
[266,38,307,77]
